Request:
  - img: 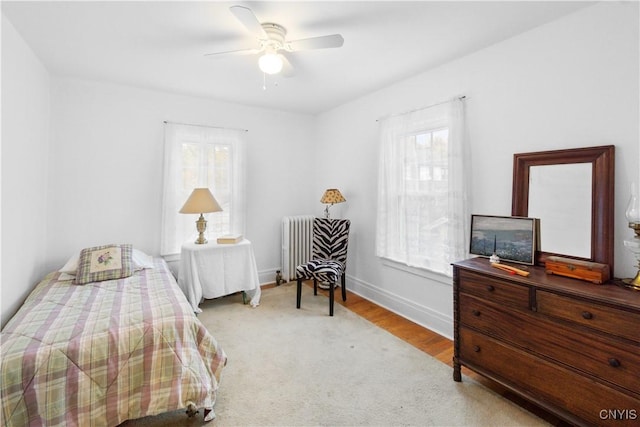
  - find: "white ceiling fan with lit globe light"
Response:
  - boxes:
[205,6,344,76]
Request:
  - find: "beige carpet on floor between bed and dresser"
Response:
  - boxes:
[125,283,546,427]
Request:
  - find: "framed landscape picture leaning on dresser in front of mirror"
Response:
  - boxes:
[469,215,538,265]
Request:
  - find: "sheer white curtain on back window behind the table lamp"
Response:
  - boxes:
[160,123,246,256]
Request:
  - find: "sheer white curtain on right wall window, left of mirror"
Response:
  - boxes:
[376,98,470,276]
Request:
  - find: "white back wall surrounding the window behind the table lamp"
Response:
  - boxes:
[47,79,314,282]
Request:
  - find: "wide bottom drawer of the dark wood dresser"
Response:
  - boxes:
[459,327,640,426]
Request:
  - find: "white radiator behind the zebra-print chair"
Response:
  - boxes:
[282,215,315,282]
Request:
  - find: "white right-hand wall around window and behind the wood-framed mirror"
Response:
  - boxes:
[315,2,640,336]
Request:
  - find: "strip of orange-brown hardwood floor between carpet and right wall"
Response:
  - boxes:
[288,281,571,427]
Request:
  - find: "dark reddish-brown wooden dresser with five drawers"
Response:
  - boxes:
[453,258,640,426]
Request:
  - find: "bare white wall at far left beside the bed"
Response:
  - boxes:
[0,15,49,326]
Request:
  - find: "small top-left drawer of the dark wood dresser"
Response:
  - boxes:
[459,270,530,310]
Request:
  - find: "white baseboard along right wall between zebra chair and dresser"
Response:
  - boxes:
[347,274,453,339]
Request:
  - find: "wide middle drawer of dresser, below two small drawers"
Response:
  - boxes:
[460,295,640,396]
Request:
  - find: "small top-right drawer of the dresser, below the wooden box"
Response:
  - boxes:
[536,291,640,342]
